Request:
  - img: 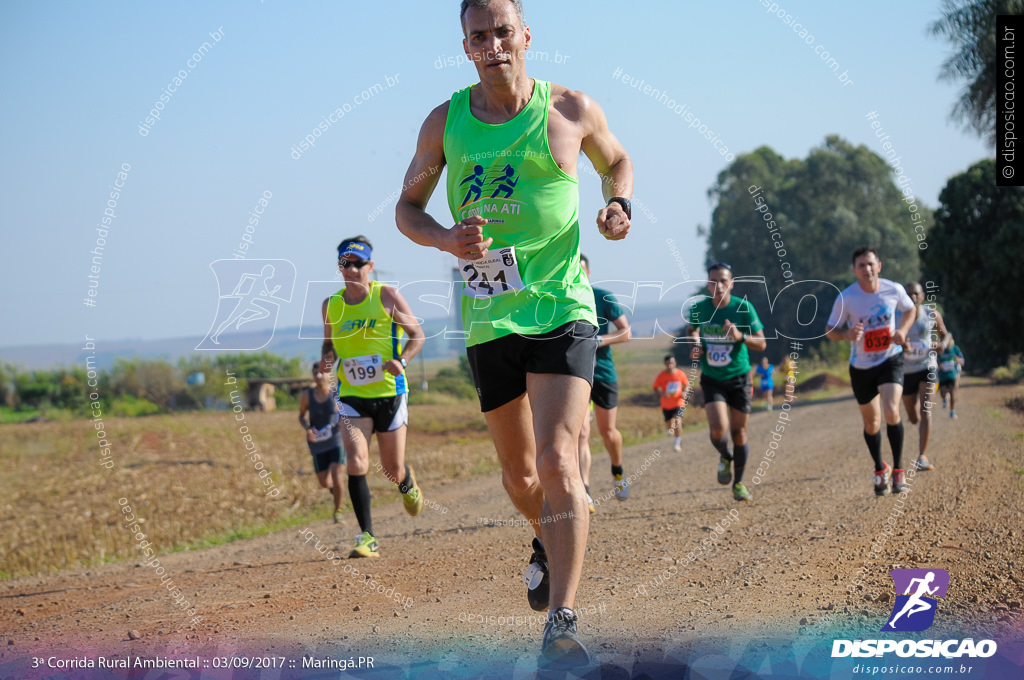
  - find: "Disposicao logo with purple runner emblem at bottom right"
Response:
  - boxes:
[831,569,996,658]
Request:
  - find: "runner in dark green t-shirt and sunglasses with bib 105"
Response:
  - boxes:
[688,262,768,501]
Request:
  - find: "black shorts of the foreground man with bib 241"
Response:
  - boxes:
[466,322,597,413]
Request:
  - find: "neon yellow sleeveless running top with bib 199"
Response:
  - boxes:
[327,281,409,399]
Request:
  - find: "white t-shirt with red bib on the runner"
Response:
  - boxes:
[828,279,913,369]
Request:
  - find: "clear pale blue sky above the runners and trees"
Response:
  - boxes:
[0,0,991,346]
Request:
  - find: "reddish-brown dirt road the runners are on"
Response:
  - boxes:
[0,386,1024,678]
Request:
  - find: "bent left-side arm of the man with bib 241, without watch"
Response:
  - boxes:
[394,101,493,260]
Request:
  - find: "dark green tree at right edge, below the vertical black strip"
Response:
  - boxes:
[921,159,1024,371]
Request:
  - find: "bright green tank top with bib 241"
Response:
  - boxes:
[444,80,597,346]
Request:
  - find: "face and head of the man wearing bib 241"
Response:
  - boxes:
[462,0,529,86]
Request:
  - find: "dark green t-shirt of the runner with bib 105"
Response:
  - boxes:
[690,295,764,380]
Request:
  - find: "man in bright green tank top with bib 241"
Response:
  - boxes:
[396,0,633,666]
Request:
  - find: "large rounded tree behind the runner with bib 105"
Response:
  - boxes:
[701,135,932,360]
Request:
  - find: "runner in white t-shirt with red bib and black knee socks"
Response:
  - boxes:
[827,247,916,496]
